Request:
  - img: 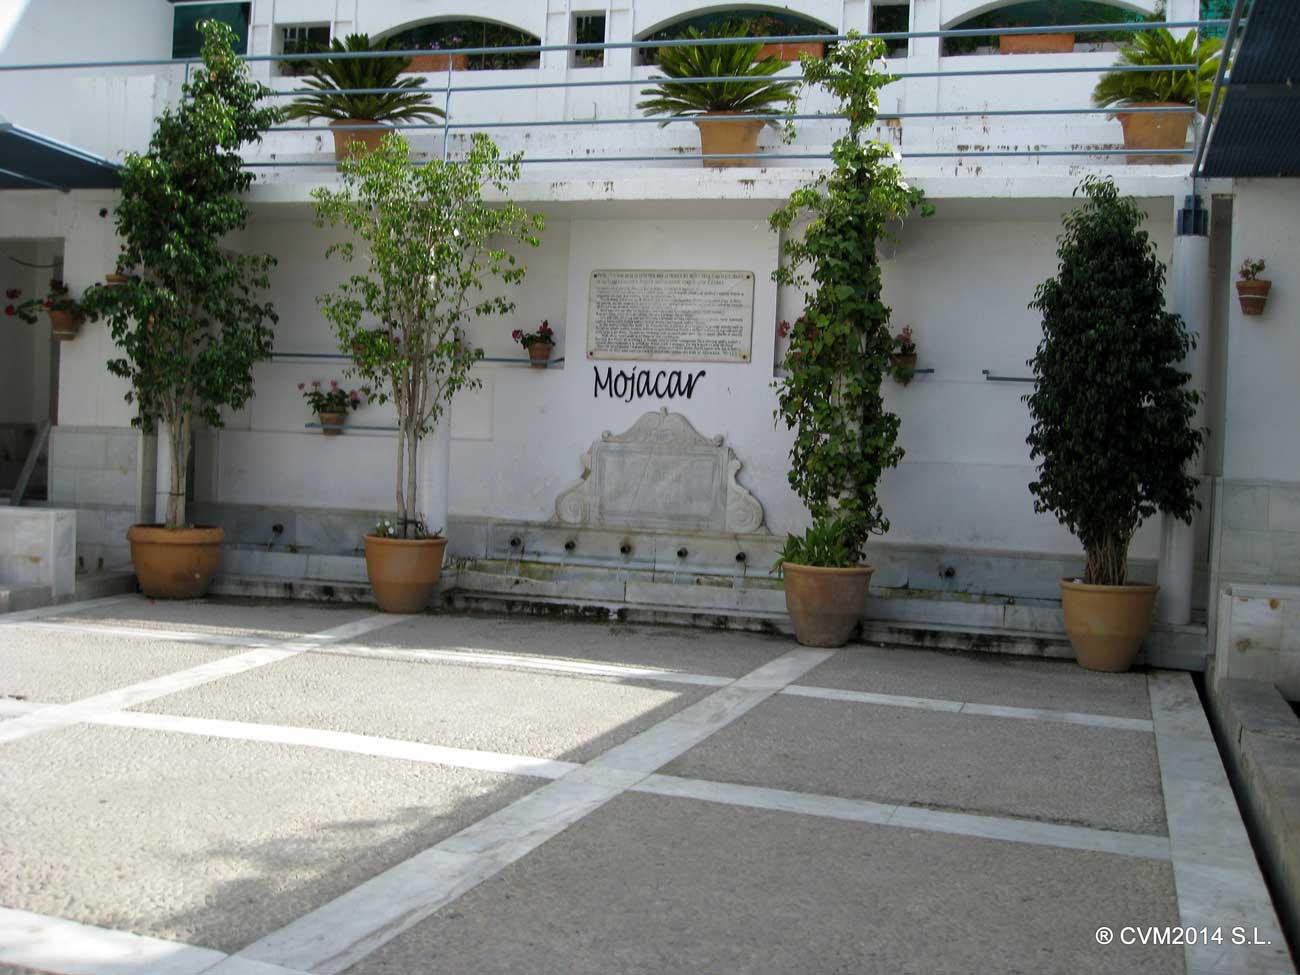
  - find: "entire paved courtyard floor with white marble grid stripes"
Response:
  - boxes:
[0,597,1294,975]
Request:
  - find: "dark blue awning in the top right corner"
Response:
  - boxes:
[1203,0,1300,177]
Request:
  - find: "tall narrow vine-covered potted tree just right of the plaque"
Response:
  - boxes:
[771,34,931,646]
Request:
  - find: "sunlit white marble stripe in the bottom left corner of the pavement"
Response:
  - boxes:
[0,907,303,975]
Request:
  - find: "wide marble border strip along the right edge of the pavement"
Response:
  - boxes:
[1147,671,1295,975]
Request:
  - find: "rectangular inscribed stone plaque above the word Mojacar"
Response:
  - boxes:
[586,270,754,363]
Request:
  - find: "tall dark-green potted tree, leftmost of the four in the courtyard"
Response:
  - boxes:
[82,21,278,598]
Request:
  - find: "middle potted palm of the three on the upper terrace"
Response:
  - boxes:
[637,25,798,168]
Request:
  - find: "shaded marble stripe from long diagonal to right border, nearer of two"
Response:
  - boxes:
[632,775,1169,861]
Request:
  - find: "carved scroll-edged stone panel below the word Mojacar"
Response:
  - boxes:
[555,408,767,533]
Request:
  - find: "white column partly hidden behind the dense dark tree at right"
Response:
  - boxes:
[1156,188,1213,624]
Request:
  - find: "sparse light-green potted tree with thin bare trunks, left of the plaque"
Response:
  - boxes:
[312,133,542,612]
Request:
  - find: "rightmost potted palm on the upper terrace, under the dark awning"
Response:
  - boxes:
[1092,27,1223,165]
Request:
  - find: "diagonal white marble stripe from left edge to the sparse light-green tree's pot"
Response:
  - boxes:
[0,614,403,745]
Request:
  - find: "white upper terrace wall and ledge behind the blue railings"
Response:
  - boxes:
[0,0,1230,199]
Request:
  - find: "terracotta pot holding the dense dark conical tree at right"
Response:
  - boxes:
[1061,579,1160,673]
